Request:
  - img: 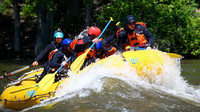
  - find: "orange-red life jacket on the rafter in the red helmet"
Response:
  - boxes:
[70,39,95,58]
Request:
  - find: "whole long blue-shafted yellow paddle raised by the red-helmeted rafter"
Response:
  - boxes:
[70,17,113,74]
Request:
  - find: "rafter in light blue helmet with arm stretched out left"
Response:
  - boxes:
[32,28,64,66]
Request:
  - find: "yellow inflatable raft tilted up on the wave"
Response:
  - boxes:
[1,50,177,110]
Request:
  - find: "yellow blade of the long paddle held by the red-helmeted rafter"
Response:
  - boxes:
[70,48,91,74]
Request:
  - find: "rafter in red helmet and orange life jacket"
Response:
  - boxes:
[70,26,101,66]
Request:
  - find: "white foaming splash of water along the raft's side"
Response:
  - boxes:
[22,53,200,111]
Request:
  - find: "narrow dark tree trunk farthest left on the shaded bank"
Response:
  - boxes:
[13,0,20,53]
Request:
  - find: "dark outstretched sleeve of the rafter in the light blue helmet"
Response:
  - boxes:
[35,41,61,62]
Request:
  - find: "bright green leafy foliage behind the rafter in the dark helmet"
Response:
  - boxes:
[97,0,200,56]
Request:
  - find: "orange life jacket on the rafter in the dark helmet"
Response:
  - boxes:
[116,22,148,47]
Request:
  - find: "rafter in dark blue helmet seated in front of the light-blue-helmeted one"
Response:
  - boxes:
[36,38,72,83]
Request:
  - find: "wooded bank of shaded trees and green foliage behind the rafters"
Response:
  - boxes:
[0,0,200,60]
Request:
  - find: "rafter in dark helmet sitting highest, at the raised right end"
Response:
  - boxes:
[102,15,156,52]
